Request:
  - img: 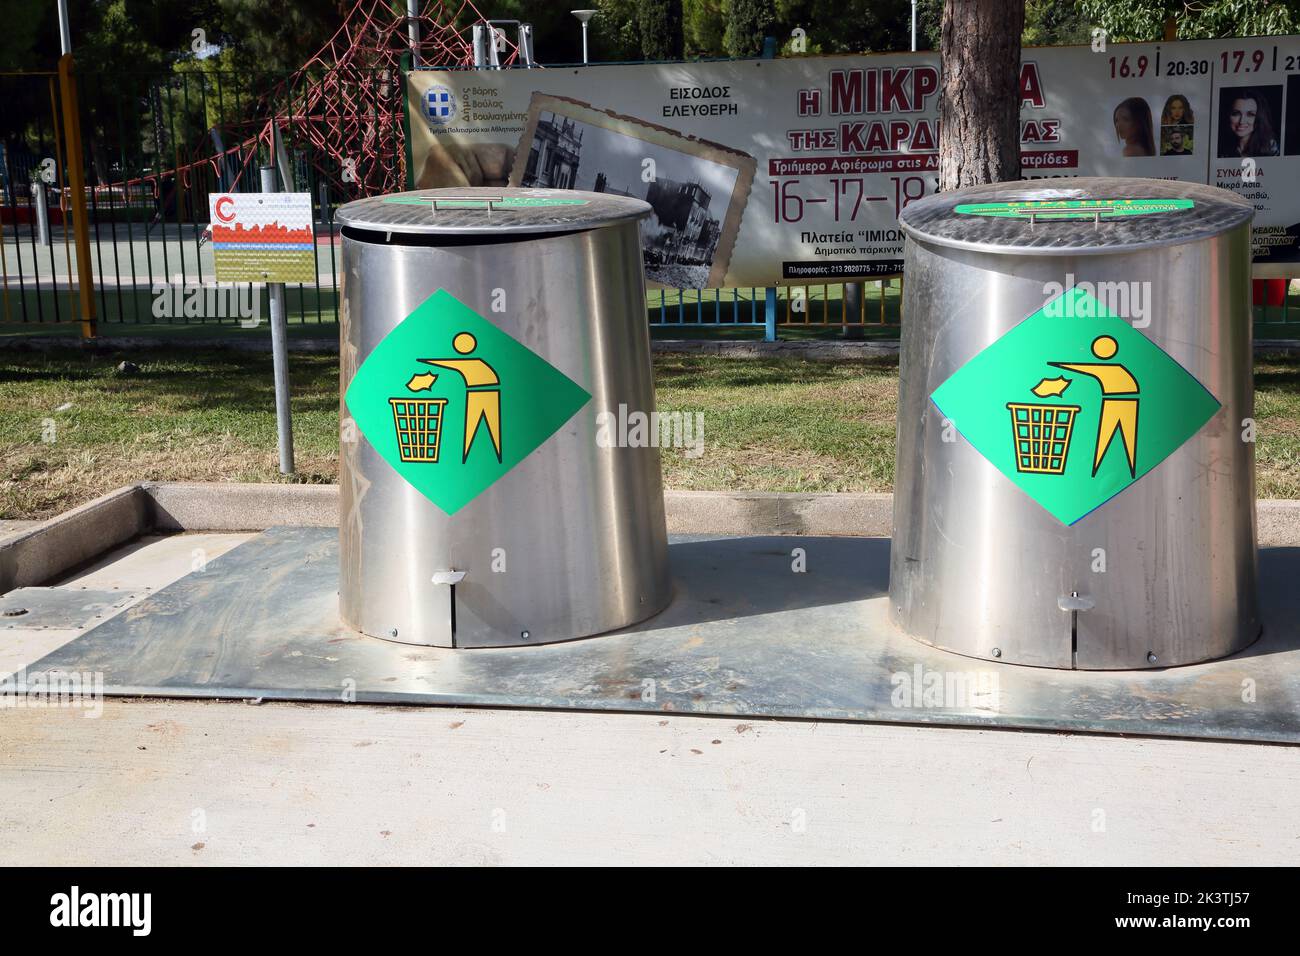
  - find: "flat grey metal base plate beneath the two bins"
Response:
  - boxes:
[20,528,1300,743]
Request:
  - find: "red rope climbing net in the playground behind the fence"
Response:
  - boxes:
[7,0,519,208]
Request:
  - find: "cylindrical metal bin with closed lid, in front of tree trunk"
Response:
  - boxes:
[889,178,1260,669]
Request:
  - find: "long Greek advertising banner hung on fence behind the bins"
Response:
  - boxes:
[408,36,1300,287]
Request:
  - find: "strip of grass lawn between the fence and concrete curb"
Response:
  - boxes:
[0,347,1300,519]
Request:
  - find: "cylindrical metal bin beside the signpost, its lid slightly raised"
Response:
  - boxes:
[338,189,671,648]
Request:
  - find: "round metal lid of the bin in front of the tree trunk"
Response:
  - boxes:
[898,177,1255,255]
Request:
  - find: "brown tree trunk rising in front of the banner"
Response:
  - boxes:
[939,0,1024,191]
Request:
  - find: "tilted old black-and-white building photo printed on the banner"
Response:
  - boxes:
[510,92,757,289]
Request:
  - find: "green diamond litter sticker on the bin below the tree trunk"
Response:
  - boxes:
[931,286,1219,524]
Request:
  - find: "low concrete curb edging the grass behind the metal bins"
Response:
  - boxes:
[0,481,1300,593]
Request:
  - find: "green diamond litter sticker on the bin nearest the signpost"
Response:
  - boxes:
[343,289,592,515]
